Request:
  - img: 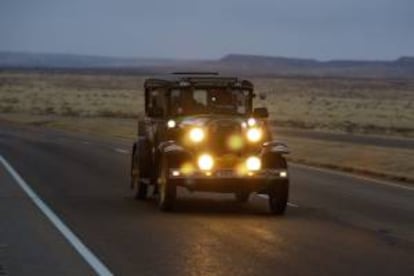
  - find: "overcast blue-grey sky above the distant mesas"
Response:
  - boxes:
[0,0,414,60]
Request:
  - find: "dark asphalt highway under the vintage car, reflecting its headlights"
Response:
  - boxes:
[0,122,414,275]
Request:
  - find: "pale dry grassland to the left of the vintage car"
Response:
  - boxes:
[0,73,144,117]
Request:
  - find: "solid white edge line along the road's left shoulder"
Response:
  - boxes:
[0,155,113,276]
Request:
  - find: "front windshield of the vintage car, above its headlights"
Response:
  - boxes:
[170,88,251,115]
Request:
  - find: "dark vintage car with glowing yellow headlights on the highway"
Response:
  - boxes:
[131,73,289,214]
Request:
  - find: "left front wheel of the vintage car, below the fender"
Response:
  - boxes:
[158,157,177,211]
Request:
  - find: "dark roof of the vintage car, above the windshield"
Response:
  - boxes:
[144,72,253,90]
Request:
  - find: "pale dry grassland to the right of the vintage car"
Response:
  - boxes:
[255,78,414,137]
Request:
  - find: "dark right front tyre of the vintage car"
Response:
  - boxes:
[268,181,289,215]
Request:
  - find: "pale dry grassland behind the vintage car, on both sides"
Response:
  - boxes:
[0,73,414,137]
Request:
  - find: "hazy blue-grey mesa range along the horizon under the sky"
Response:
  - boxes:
[0,51,414,78]
